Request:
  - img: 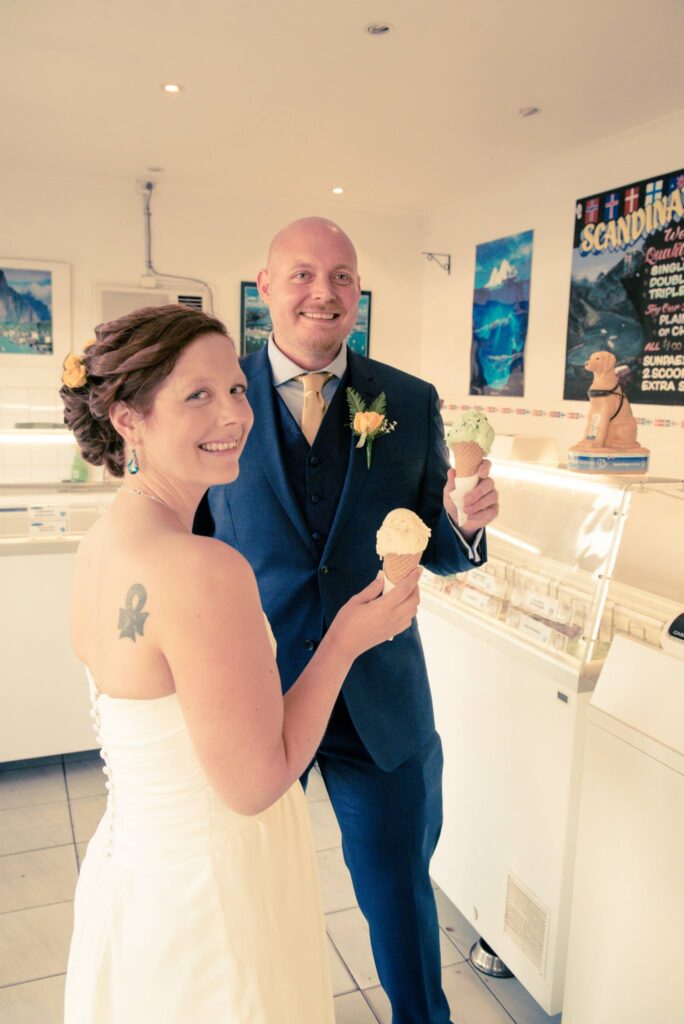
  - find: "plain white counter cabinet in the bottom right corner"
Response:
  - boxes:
[563,637,684,1024]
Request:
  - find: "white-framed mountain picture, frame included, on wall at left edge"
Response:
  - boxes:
[0,256,72,369]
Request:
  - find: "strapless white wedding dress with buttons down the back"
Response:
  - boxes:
[65,626,335,1024]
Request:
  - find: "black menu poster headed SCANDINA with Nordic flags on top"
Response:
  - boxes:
[563,171,684,406]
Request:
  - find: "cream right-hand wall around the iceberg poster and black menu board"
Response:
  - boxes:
[422,112,684,476]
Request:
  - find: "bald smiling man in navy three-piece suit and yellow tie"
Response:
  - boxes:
[196,217,498,1024]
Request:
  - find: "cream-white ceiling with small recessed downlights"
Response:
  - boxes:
[0,0,684,210]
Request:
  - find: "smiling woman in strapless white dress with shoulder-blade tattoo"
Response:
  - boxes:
[60,306,419,1024]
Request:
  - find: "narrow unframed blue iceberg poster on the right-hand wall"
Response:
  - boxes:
[470,231,533,396]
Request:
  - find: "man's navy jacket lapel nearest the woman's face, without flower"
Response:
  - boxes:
[243,347,318,561]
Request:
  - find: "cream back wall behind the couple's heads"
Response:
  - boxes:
[0,171,425,482]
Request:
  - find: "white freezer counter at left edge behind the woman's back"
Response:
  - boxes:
[0,485,116,762]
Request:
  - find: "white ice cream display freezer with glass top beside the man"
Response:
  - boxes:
[419,462,684,1024]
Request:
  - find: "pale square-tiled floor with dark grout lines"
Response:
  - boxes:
[0,753,560,1024]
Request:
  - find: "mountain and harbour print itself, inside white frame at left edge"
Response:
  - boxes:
[0,262,53,358]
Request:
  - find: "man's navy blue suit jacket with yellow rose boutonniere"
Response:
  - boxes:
[195,348,484,770]
